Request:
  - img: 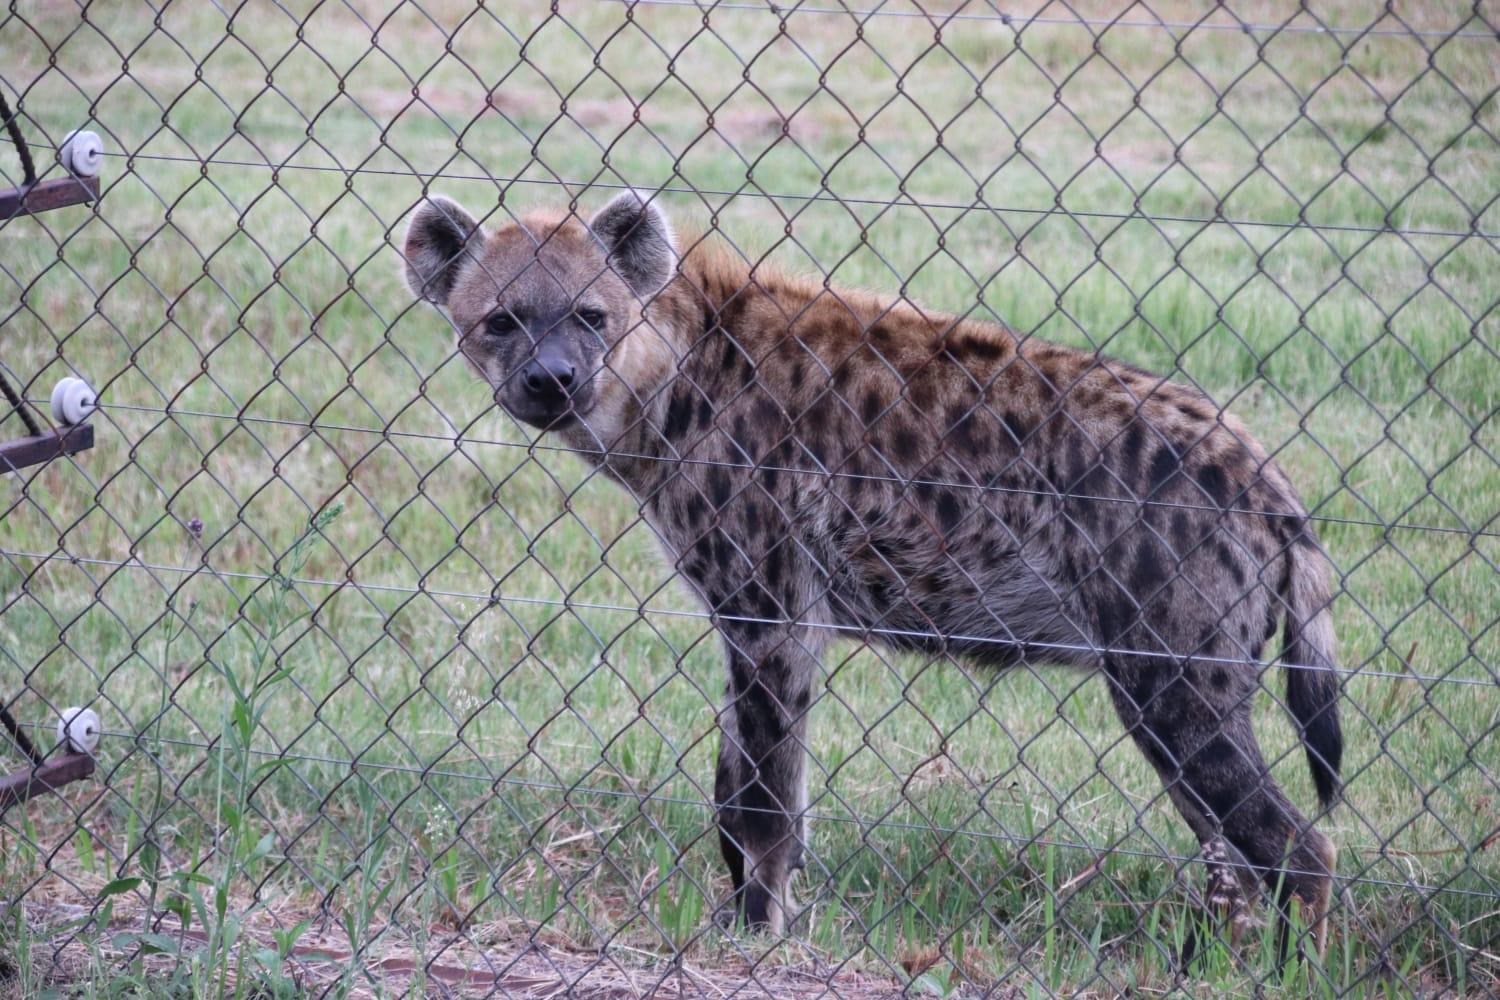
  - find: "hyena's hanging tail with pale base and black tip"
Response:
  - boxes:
[1281,528,1344,807]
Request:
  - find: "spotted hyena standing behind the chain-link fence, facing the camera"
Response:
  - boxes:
[405,192,1343,946]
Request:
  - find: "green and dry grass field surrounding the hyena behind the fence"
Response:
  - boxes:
[0,0,1500,996]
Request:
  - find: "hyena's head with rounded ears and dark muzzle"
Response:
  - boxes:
[404,190,677,434]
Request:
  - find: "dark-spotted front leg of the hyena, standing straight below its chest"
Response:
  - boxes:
[714,622,818,934]
